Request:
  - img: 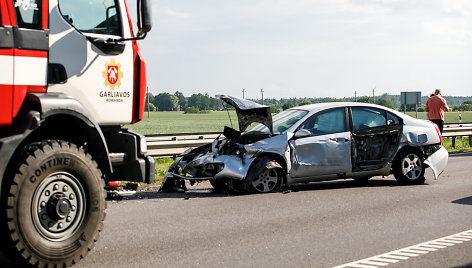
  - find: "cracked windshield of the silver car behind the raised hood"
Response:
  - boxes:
[247,110,308,135]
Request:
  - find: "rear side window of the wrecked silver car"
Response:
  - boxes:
[352,107,387,131]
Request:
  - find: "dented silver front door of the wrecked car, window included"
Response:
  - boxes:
[289,107,351,178]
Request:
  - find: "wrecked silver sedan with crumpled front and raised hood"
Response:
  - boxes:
[161,96,448,193]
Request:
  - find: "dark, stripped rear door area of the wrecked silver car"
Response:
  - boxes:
[350,106,403,171]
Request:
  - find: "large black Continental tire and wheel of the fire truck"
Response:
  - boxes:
[1,141,106,267]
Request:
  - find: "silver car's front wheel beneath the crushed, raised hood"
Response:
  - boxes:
[244,157,282,193]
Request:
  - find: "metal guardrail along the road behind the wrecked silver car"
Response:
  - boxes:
[146,123,472,157]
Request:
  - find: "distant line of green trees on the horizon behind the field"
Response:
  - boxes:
[146,91,472,113]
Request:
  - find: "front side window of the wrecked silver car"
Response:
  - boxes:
[300,108,346,136]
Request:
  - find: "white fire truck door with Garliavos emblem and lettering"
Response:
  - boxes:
[48,0,135,125]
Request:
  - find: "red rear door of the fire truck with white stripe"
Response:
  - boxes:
[0,0,48,126]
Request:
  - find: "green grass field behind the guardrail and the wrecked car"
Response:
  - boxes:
[127,111,472,135]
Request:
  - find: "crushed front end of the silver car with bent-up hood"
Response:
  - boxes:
[160,96,286,191]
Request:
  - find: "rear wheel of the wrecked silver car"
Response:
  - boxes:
[393,150,425,185]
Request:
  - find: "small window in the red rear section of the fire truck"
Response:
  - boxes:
[13,0,42,30]
